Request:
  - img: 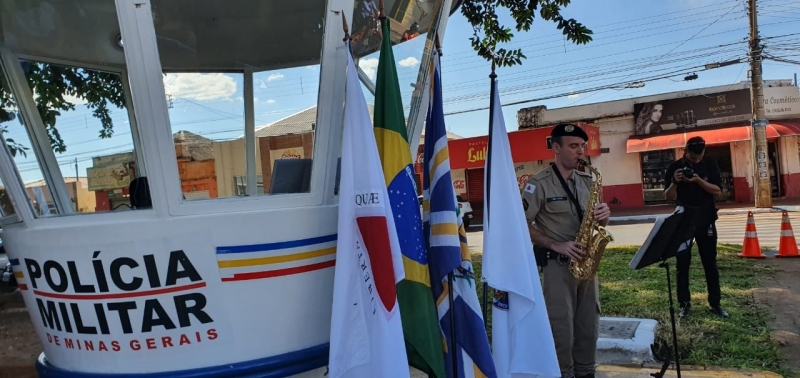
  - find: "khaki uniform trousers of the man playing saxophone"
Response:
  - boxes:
[542,259,600,378]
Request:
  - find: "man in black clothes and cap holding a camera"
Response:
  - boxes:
[664,137,728,318]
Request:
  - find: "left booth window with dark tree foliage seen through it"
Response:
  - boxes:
[0,0,150,216]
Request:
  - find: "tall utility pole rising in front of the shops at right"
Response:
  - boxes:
[748,0,772,208]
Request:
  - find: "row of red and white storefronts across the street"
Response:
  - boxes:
[416,80,800,218]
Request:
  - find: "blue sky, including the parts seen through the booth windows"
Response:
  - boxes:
[3,0,800,182]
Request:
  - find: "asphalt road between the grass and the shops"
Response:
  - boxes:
[467,213,800,252]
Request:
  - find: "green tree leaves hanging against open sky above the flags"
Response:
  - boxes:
[461,0,592,67]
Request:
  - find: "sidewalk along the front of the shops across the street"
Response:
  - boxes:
[609,198,800,225]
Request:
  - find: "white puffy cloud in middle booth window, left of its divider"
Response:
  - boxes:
[164,73,236,101]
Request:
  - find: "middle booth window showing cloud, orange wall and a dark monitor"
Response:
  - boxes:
[145,0,327,200]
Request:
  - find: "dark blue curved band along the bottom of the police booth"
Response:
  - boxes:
[36,344,329,378]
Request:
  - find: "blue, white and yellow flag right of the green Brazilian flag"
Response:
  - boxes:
[422,53,497,378]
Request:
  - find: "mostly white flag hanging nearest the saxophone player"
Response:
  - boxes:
[482,80,561,378]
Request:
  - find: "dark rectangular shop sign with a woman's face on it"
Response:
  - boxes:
[633,89,752,135]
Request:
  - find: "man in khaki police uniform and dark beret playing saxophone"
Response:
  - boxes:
[522,124,611,378]
